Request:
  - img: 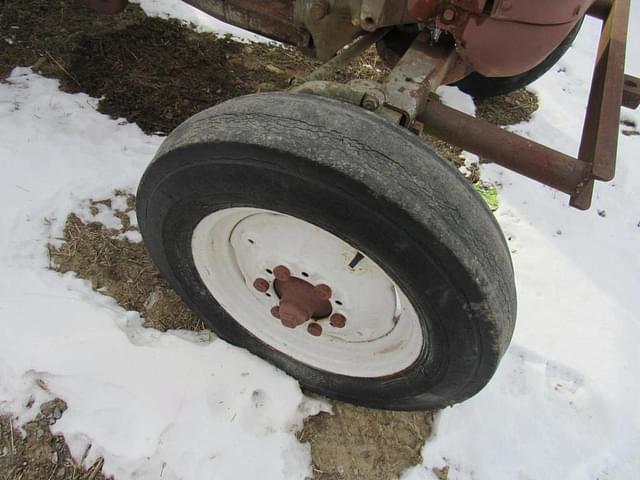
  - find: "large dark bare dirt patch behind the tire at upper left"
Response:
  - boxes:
[0,0,386,133]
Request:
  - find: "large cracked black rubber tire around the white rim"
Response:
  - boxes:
[137,93,516,410]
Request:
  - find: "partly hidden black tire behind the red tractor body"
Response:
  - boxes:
[453,17,584,98]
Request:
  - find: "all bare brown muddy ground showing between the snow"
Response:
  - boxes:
[0,0,538,480]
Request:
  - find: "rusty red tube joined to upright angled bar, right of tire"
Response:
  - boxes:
[417,0,640,210]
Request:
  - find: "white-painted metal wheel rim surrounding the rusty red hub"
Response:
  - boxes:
[191,207,424,378]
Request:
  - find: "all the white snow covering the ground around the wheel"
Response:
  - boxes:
[0,0,640,480]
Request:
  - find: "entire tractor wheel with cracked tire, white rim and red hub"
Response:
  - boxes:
[137,93,516,410]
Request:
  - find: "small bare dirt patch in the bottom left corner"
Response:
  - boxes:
[0,400,107,480]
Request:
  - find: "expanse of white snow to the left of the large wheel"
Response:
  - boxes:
[0,68,326,480]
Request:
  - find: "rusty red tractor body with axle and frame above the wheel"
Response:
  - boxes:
[85,0,640,210]
